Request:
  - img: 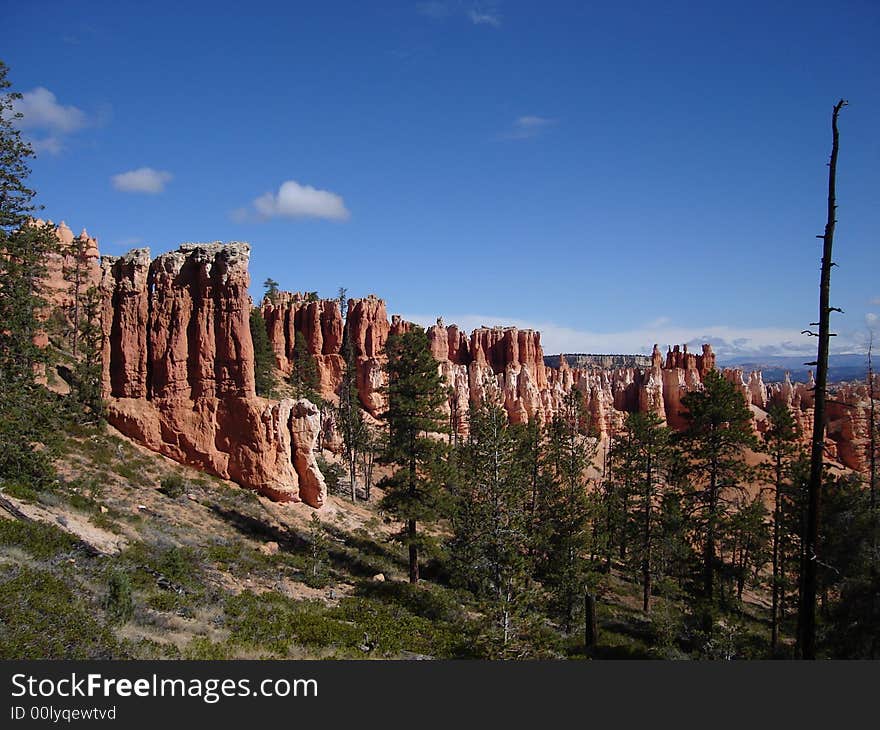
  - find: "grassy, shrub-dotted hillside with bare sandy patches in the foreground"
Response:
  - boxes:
[0,420,768,659]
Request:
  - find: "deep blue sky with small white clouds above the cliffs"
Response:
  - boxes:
[6,0,880,356]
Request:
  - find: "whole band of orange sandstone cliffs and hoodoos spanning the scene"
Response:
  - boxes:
[47,224,880,500]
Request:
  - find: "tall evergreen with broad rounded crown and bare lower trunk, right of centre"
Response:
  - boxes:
[678,370,756,616]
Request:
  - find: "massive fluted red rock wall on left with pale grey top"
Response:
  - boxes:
[101,243,326,507]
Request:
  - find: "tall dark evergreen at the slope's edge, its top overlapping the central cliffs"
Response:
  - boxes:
[379,327,448,583]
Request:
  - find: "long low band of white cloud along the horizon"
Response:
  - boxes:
[403,314,863,360]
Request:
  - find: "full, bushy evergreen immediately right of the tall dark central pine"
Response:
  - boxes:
[450,399,531,654]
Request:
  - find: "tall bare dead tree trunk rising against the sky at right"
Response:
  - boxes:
[798,99,846,659]
